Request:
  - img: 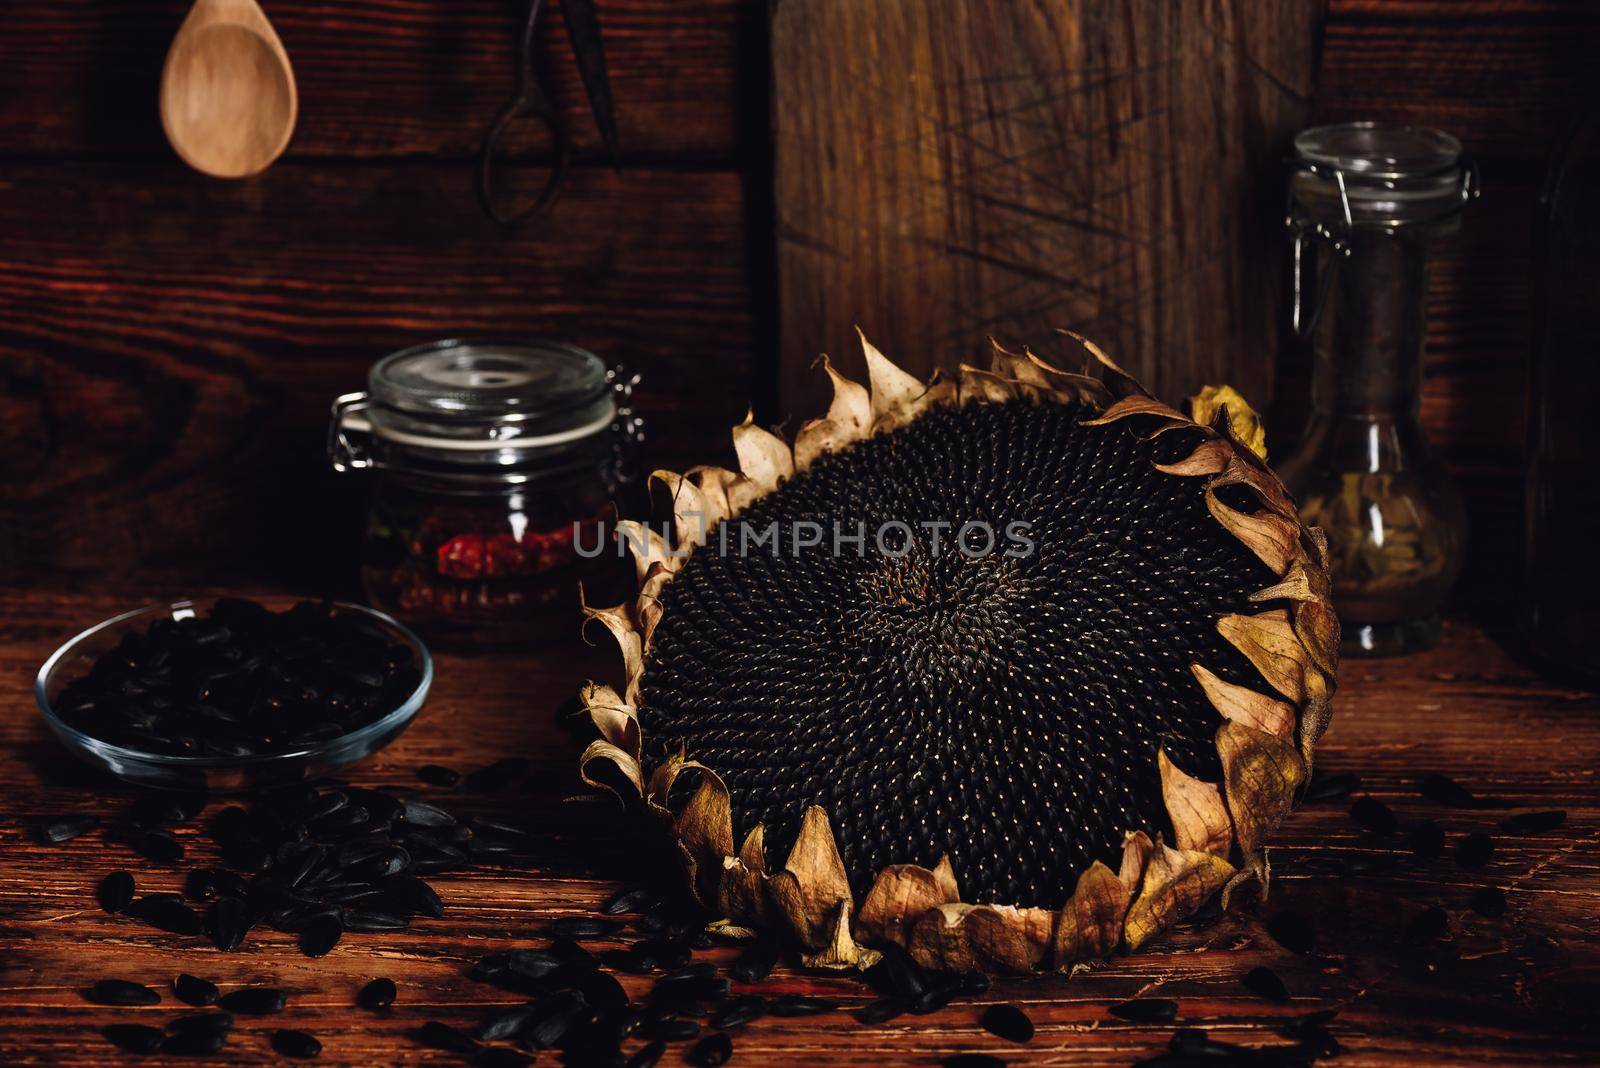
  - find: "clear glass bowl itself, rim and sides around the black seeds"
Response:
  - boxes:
[34,596,434,793]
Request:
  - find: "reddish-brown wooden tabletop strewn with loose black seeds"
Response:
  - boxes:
[0,590,1600,1065]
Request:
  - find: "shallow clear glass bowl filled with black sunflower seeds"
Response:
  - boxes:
[34,596,434,791]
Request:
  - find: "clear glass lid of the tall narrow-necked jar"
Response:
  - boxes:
[1293,123,1475,225]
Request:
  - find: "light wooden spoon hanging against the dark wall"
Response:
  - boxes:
[162,0,299,177]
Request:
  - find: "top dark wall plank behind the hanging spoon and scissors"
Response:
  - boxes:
[0,0,741,160]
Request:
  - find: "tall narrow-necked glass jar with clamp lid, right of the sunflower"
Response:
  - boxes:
[1277,123,1477,656]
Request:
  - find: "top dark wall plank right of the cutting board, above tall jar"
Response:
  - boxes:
[1317,0,1600,160]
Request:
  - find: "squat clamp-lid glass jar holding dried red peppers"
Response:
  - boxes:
[328,341,640,644]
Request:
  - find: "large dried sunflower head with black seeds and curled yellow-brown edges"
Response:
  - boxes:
[582,339,1338,969]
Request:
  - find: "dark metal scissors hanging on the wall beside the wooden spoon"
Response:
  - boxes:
[478,0,621,225]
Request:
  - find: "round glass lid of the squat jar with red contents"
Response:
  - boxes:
[366,339,616,444]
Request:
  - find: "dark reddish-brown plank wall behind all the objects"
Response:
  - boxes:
[0,0,1600,601]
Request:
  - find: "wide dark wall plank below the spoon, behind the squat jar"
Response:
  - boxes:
[0,163,749,577]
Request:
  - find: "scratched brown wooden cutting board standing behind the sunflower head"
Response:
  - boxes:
[773,0,1320,411]
